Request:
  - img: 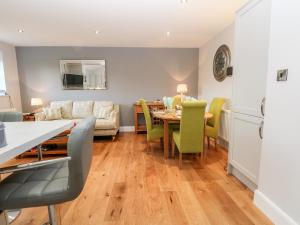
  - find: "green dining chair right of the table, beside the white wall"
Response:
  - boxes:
[205,98,226,150]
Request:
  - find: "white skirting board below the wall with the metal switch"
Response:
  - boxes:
[254,190,297,225]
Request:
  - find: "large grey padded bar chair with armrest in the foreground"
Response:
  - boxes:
[0,117,96,225]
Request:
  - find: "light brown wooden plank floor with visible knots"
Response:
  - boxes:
[7,133,272,225]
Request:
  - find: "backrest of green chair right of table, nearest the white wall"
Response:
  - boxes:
[207,97,225,130]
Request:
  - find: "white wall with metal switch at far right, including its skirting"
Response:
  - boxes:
[255,0,300,225]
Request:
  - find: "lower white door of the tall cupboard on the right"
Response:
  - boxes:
[229,113,263,184]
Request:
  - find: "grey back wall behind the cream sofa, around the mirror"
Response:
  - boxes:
[16,47,199,126]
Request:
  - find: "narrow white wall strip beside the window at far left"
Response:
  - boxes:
[0,42,22,111]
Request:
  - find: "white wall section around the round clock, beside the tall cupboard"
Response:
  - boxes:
[198,24,234,102]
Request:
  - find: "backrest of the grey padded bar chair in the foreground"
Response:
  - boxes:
[68,116,96,196]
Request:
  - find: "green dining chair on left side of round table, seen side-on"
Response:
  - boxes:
[140,99,164,150]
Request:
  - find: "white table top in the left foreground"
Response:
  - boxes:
[0,120,74,163]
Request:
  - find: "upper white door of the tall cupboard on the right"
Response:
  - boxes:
[232,0,270,117]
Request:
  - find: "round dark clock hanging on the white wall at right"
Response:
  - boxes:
[213,45,231,82]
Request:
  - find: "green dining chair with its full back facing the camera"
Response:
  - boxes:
[172,101,206,168]
